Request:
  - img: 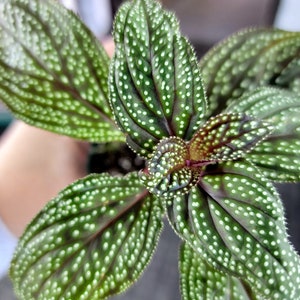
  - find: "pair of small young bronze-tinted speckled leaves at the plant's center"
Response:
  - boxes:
[140,113,272,198]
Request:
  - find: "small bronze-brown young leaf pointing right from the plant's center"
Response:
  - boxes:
[189,110,272,164]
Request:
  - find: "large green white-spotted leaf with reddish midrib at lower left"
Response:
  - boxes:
[10,173,162,300]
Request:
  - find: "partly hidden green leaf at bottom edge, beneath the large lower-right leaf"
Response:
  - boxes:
[179,243,261,300]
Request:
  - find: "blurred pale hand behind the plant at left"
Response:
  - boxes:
[0,121,88,236]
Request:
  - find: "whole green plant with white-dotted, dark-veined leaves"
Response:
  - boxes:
[0,0,300,300]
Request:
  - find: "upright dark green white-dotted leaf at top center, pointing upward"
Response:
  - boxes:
[110,0,206,157]
